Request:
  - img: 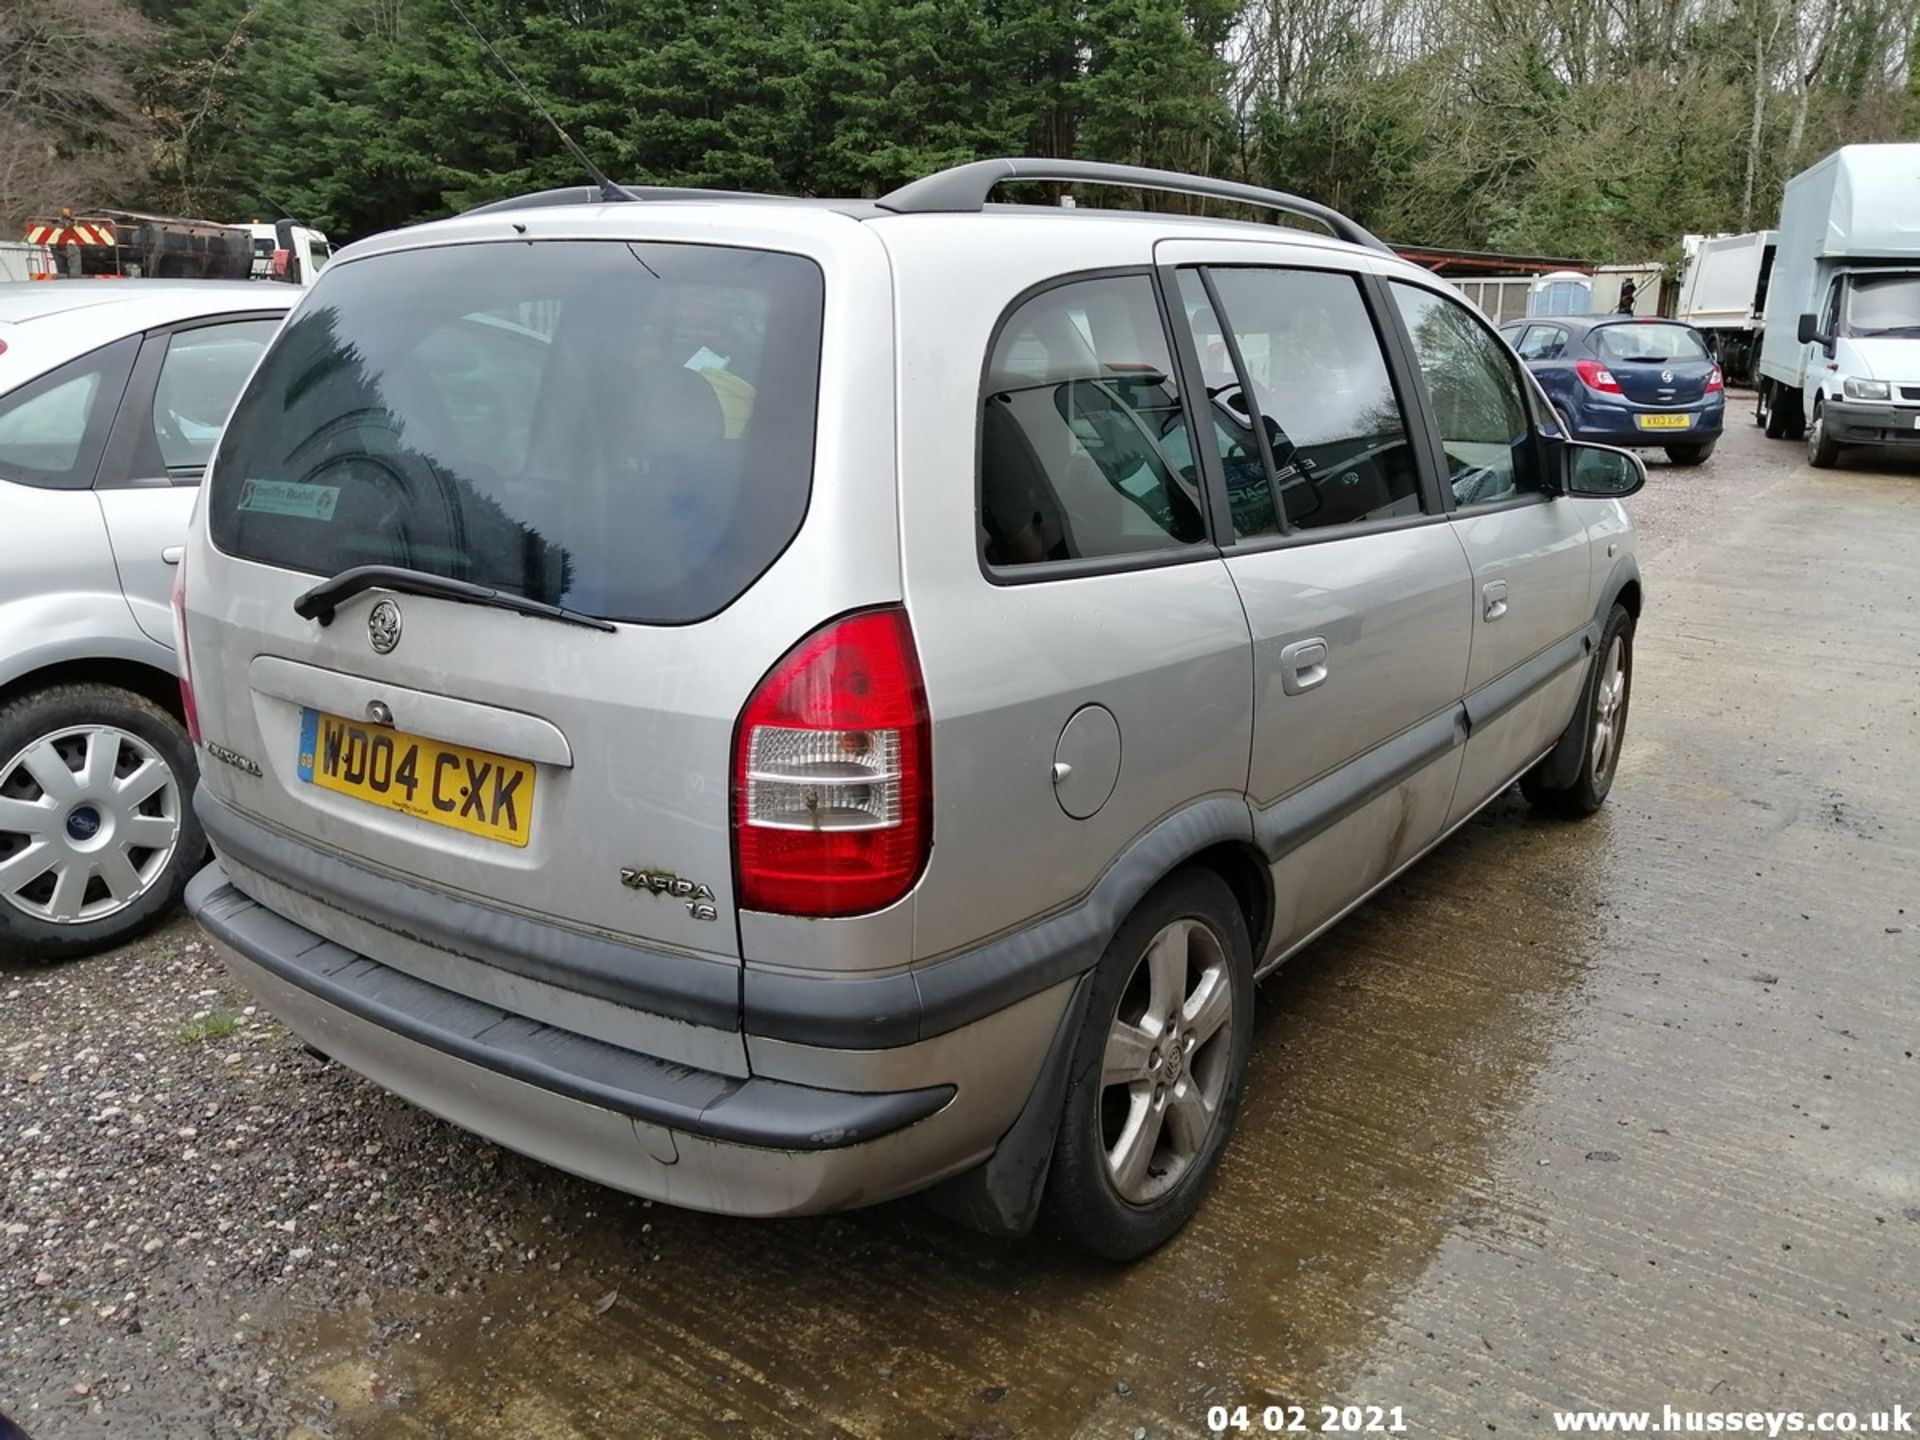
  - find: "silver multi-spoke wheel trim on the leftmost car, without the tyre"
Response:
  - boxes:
[0,726,182,925]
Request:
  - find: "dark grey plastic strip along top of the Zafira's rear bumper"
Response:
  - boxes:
[186,864,954,1150]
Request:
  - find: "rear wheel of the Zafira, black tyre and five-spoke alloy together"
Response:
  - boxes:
[1046,868,1254,1260]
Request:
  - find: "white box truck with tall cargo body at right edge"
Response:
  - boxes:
[1755,144,1920,467]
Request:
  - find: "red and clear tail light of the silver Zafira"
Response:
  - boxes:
[733,607,933,916]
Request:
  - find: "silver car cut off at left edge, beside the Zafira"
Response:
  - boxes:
[0,280,294,960]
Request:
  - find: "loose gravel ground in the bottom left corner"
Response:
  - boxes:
[0,920,637,1440]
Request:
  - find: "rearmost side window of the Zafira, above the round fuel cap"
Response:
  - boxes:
[979,275,1206,566]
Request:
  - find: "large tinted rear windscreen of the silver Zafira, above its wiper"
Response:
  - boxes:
[207,240,822,624]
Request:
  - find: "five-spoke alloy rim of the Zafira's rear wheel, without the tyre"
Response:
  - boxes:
[1098,920,1238,1206]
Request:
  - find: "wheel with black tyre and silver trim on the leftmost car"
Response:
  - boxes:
[0,684,207,960]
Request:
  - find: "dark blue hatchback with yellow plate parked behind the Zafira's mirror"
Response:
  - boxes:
[1500,315,1726,465]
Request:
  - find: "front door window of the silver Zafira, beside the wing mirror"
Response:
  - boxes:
[1394,280,1542,507]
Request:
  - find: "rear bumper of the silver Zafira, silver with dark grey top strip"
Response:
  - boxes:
[186,864,1066,1215]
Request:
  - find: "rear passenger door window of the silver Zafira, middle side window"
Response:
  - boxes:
[1188,267,1421,534]
